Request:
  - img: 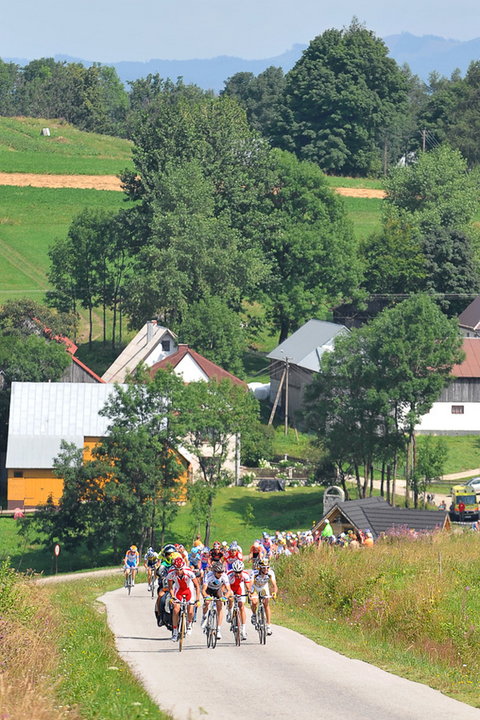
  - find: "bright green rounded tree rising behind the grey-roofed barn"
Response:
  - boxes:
[263,150,360,341]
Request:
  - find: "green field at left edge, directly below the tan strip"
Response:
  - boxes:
[0,186,131,302]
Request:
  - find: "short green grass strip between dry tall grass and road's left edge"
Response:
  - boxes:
[48,578,171,720]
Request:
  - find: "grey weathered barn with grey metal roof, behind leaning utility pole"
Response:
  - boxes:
[267,320,349,418]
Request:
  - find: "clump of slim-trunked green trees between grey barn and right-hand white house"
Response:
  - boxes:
[307,295,462,504]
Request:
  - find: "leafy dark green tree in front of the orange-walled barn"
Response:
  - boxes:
[95,371,186,545]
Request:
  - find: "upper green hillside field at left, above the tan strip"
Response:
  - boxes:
[0,117,133,175]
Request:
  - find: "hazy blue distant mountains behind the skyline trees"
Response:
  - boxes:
[3,33,480,92]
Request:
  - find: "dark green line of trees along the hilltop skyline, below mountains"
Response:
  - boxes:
[0,18,480,176]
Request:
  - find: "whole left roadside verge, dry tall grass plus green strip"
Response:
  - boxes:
[0,565,170,720]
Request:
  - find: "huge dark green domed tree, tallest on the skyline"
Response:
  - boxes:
[277,19,407,175]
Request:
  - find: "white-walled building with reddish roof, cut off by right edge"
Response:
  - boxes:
[415,337,480,435]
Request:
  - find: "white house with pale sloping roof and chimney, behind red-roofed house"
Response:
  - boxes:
[102,320,177,383]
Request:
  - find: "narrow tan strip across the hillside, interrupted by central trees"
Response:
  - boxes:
[0,173,385,198]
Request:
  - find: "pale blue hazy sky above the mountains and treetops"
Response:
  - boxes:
[0,0,480,62]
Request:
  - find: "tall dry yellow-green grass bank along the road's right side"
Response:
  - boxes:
[273,533,480,707]
